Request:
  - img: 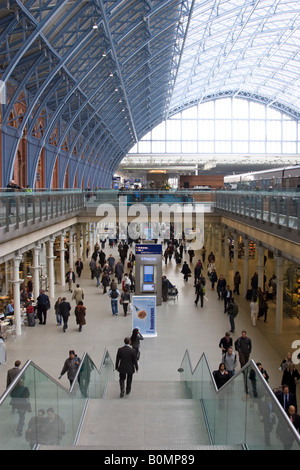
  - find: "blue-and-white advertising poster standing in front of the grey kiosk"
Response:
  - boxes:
[132,295,157,338]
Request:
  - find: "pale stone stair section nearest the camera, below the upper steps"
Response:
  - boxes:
[78,395,209,449]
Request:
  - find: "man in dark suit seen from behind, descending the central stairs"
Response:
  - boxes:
[115,336,139,398]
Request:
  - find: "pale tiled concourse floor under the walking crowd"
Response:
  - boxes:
[0,242,300,408]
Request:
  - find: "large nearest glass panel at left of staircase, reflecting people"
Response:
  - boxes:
[0,362,85,450]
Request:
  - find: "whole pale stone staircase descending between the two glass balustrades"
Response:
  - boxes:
[40,380,241,451]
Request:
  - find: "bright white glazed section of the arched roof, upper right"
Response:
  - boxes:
[169,0,300,119]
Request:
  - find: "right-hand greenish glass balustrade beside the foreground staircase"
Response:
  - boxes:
[181,353,300,450]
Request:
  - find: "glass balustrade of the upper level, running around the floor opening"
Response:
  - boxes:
[0,189,300,238]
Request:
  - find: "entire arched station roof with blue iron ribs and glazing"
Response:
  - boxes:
[0,0,300,184]
